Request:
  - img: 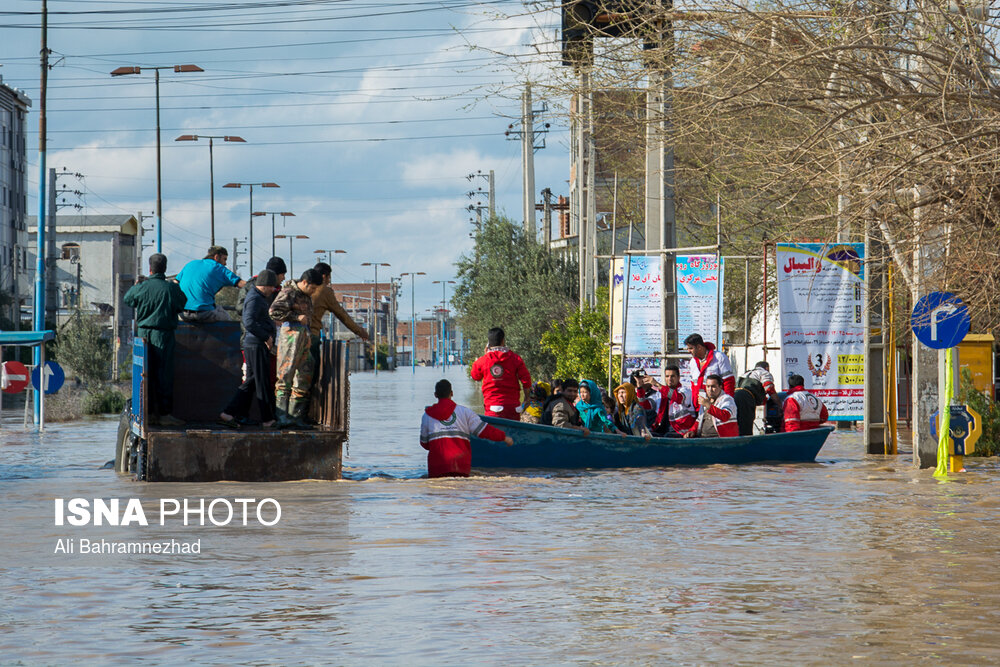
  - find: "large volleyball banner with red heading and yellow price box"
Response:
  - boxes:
[776,243,865,421]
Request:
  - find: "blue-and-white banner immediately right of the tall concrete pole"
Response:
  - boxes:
[676,255,726,352]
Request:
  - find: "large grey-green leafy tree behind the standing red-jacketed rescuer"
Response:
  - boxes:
[452,217,578,377]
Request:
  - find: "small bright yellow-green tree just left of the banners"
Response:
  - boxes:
[542,288,610,387]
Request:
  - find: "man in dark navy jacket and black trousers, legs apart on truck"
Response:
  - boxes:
[219,269,278,428]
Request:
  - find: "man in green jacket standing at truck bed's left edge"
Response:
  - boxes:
[125,253,187,426]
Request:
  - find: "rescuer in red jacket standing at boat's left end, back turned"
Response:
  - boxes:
[472,327,531,421]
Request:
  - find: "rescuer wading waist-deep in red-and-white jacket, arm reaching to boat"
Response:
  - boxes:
[420,380,514,477]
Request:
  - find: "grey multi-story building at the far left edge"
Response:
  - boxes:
[0,77,32,321]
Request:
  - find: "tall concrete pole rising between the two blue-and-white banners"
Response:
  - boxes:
[646,0,679,354]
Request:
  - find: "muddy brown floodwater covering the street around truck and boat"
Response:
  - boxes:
[0,368,1000,665]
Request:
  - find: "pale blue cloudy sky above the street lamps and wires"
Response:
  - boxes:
[0,0,569,317]
